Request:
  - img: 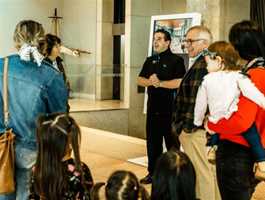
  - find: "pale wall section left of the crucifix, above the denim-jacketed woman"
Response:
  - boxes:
[0,0,61,57]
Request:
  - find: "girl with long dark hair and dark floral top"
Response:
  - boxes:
[29,113,93,200]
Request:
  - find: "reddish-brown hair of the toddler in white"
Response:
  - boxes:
[208,41,242,71]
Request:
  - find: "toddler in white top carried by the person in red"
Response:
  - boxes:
[194,41,265,178]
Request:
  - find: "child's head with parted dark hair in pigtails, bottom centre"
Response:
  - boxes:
[91,170,149,200]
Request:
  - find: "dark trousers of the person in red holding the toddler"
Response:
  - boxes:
[216,140,257,200]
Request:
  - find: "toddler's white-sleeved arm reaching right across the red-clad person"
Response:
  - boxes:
[238,75,265,109]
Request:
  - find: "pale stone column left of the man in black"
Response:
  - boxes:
[124,0,161,138]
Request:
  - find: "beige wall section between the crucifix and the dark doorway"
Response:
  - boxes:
[61,0,97,99]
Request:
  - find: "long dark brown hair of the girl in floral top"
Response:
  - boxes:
[33,113,83,200]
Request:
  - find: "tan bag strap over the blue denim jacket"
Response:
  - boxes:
[3,57,9,128]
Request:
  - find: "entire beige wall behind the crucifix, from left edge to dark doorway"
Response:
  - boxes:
[0,0,97,98]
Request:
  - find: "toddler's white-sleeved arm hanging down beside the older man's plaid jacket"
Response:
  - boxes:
[193,82,207,126]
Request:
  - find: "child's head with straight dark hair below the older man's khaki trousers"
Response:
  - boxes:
[151,150,196,200]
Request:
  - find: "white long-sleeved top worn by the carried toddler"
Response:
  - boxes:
[194,71,265,126]
